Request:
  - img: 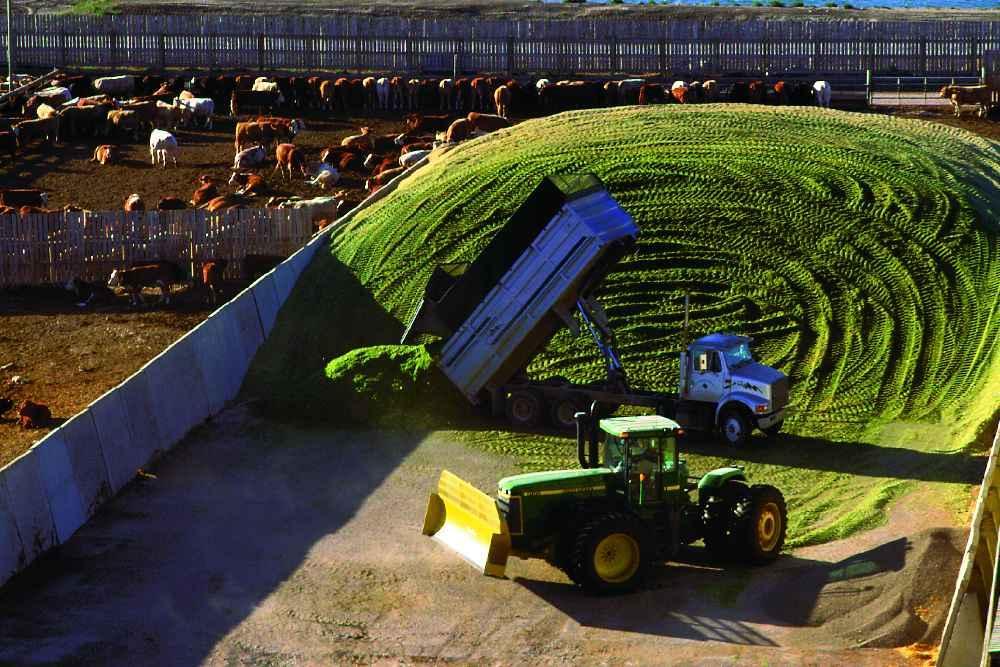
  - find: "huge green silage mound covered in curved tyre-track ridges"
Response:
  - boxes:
[251,105,1000,544]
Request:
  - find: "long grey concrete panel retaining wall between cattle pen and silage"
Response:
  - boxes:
[0,158,428,584]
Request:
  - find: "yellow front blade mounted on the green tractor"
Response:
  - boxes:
[424,470,510,577]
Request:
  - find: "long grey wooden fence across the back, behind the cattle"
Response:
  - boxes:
[0,15,1000,75]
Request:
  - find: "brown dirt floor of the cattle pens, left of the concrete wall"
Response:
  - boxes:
[0,109,412,466]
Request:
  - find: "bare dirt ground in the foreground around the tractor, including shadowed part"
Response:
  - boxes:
[0,407,964,666]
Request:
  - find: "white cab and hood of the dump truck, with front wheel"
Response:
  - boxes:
[678,333,788,445]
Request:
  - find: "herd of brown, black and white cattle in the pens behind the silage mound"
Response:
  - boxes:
[0,66,988,310]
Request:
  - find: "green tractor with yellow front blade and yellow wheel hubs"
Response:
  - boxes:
[424,413,788,592]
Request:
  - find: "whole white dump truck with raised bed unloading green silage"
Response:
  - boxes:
[402,174,788,445]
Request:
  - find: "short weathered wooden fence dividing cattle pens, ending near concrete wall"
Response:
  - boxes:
[0,209,312,287]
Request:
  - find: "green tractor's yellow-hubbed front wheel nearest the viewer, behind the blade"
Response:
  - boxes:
[570,512,654,593]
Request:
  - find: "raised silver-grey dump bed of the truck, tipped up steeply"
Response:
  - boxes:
[428,174,639,403]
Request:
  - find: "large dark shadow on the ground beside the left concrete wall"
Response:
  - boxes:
[0,409,423,665]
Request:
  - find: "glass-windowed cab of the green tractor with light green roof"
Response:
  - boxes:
[600,415,688,507]
